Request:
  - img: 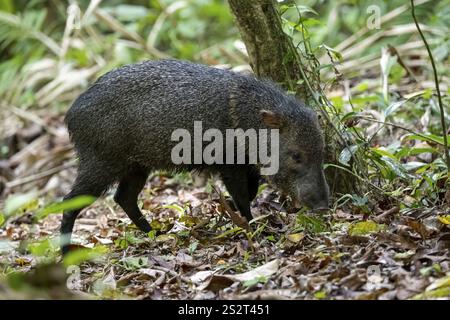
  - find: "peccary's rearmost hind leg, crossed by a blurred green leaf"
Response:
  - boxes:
[60,167,111,255]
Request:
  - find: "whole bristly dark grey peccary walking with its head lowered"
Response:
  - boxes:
[61,60,329,253]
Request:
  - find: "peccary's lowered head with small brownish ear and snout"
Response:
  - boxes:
[260,101,329,210]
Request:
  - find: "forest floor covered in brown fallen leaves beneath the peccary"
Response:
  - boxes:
[0,113,450,299]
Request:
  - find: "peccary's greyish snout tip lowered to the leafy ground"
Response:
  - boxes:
[297,167,330,211]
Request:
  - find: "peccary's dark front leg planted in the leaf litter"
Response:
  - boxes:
[221,166,253,221]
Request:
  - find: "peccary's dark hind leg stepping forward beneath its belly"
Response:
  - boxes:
[114,167,151,233]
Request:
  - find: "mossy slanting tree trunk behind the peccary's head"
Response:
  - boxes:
[228,0,358,193]
